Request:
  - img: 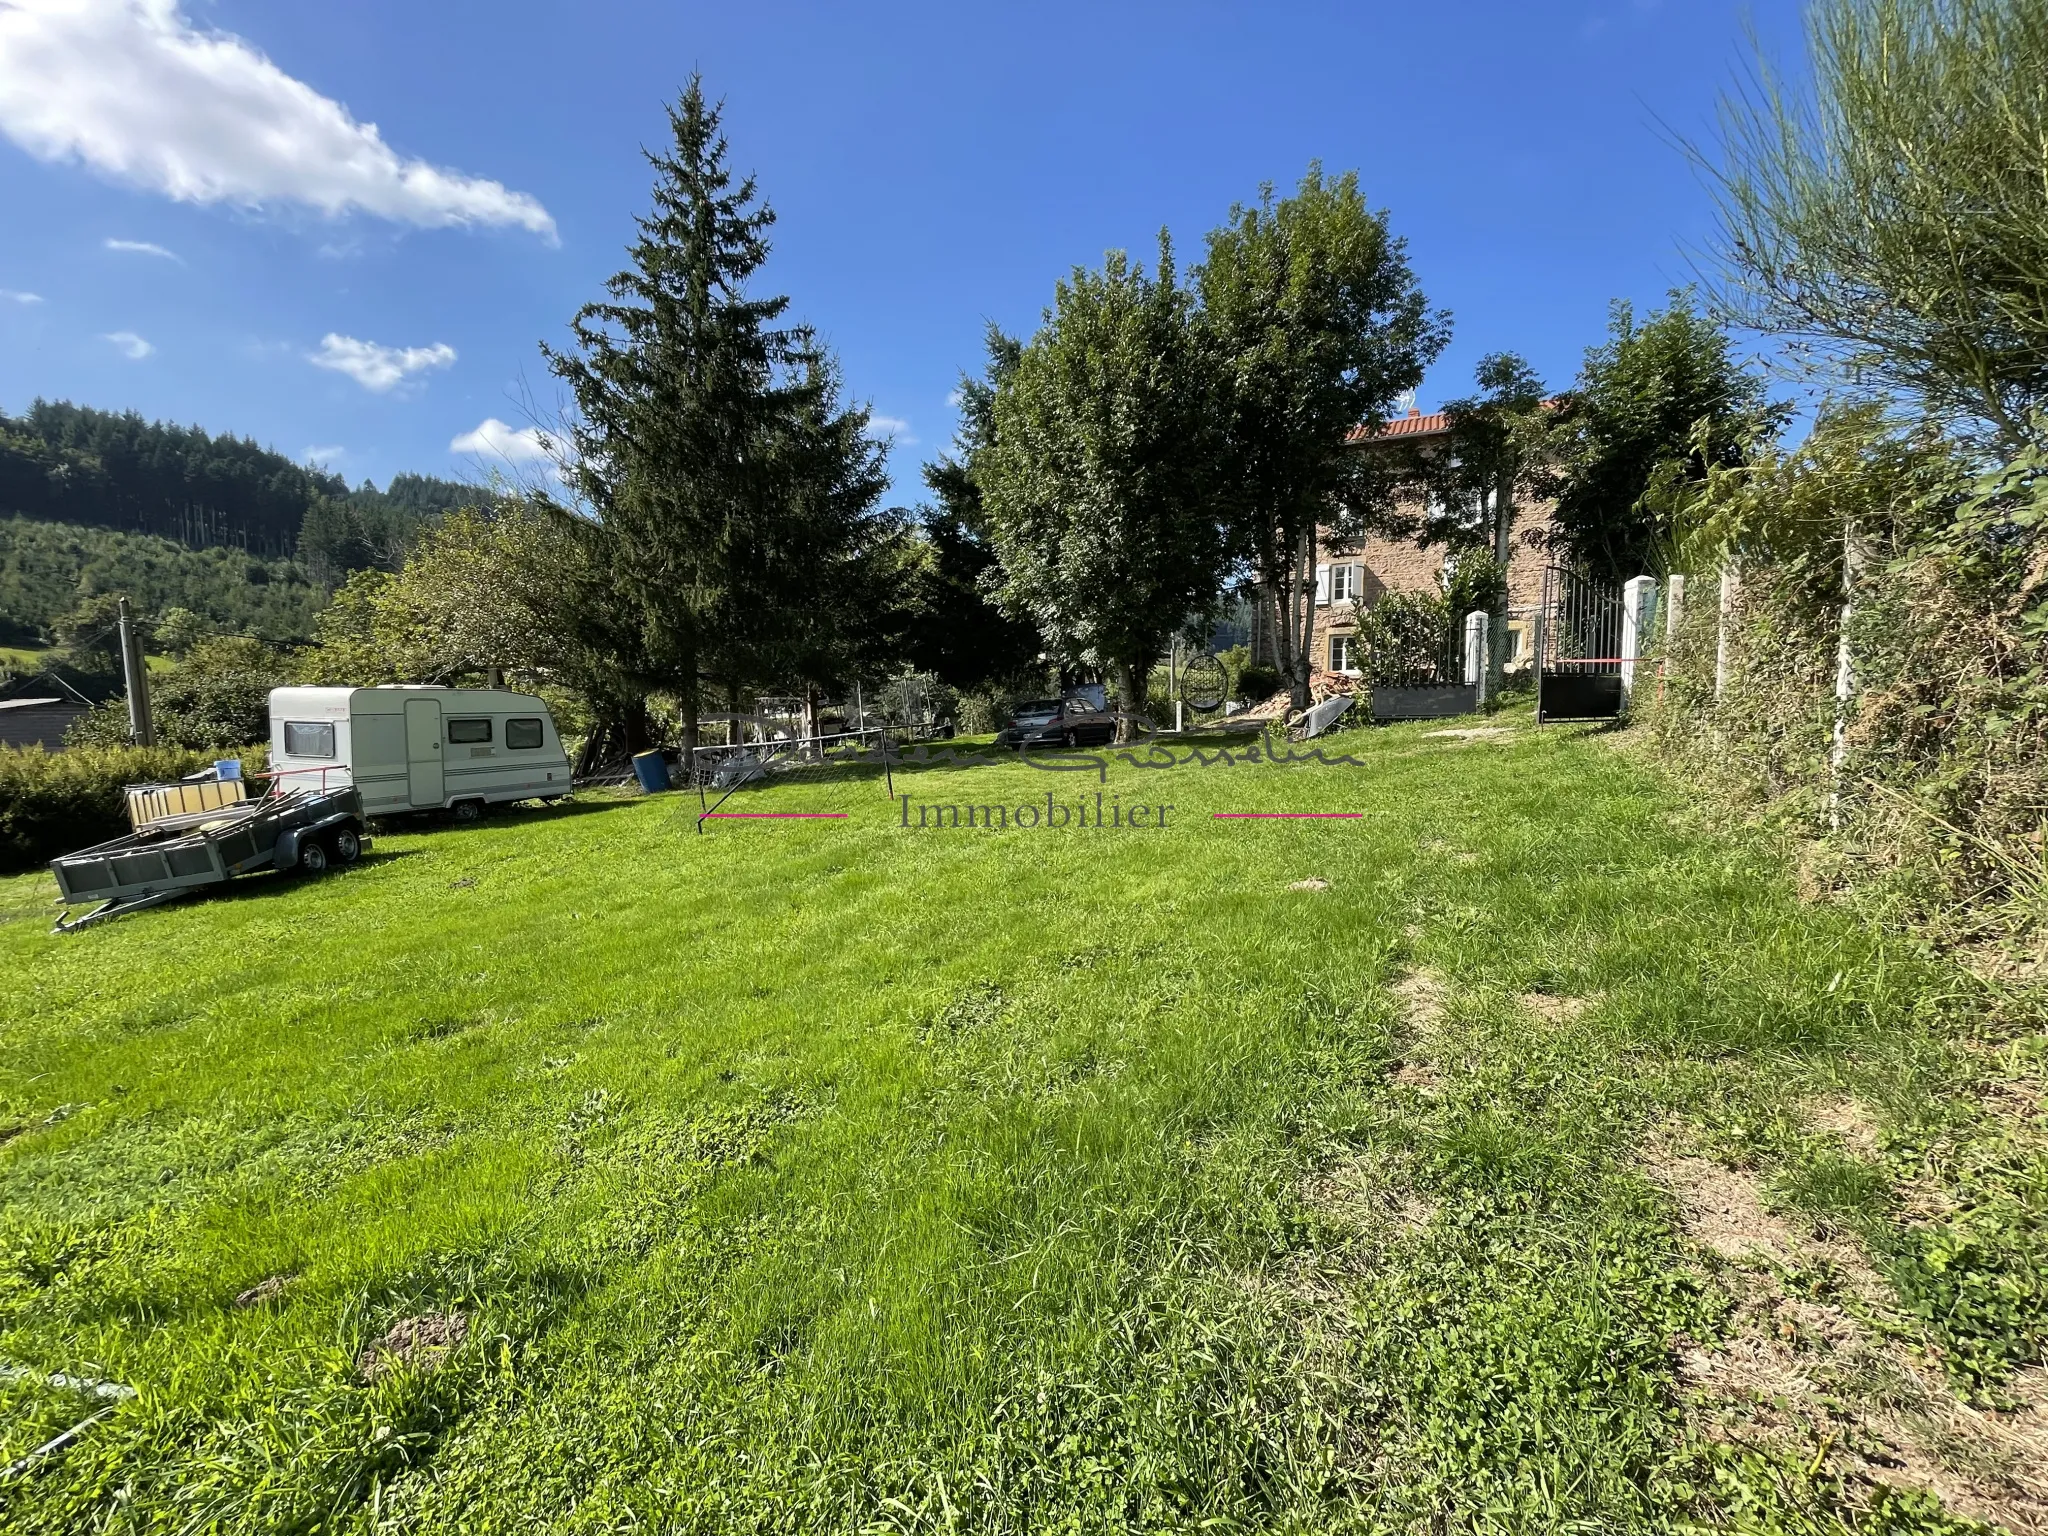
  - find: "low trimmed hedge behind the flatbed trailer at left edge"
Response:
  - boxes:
[0,748,268,874]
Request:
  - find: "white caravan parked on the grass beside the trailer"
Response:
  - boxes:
[270,684,569,819]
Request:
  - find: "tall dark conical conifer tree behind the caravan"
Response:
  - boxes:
[547,80,895,745]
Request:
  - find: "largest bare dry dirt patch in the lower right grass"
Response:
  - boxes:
[1651,1155,2048,1536]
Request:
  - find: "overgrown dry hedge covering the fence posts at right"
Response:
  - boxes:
[1642,406,2048,938]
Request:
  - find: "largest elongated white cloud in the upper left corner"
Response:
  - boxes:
[0,0,555,242]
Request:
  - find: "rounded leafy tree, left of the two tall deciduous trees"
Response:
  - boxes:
[973,236,1225,729]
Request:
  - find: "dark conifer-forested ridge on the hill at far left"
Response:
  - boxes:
[0,399,479,581]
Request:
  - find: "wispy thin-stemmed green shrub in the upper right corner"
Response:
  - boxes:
[1700,0,2048,453]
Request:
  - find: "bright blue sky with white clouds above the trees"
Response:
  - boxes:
[0,0,1800,502]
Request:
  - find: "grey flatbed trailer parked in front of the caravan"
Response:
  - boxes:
[49,782,371,934]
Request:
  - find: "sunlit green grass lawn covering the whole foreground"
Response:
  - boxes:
[0,727,2048,1532]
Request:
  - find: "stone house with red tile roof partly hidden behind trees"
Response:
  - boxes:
[1311,410,1554,690]
